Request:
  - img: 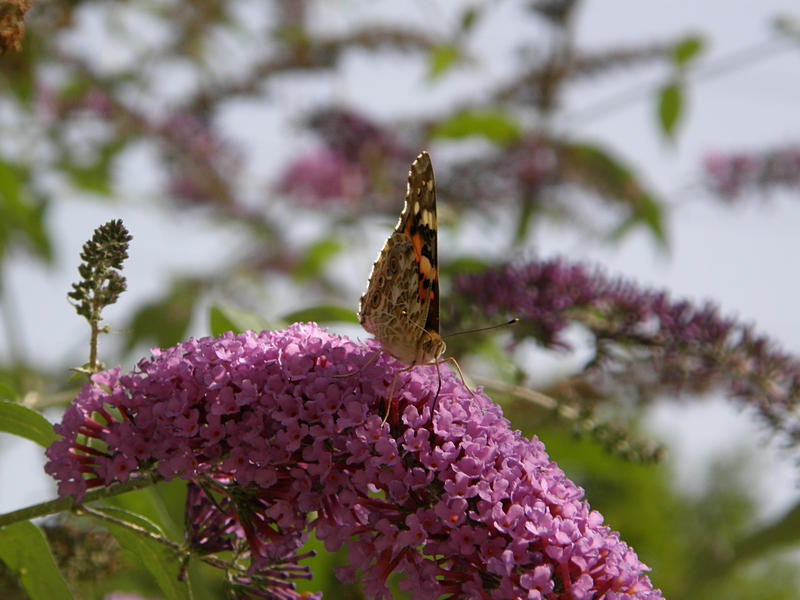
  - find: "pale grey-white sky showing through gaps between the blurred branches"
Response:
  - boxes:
[0,0,800,519]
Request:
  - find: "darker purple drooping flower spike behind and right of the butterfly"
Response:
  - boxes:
[454,260,800,445]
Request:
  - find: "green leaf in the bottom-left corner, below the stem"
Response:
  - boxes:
[0,521,73,600]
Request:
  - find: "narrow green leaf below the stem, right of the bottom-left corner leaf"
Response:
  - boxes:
[103,521,191,600]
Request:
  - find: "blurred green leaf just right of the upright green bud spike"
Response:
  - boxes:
[125,280,202,352]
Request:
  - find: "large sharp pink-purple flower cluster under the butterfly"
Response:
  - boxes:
[46,324,661,600]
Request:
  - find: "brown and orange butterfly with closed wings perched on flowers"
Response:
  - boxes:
[358,152,460,421]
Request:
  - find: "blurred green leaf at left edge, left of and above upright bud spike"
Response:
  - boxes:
[0,161,52,261]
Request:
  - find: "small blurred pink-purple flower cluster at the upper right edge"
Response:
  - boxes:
[704,146,800,200]
